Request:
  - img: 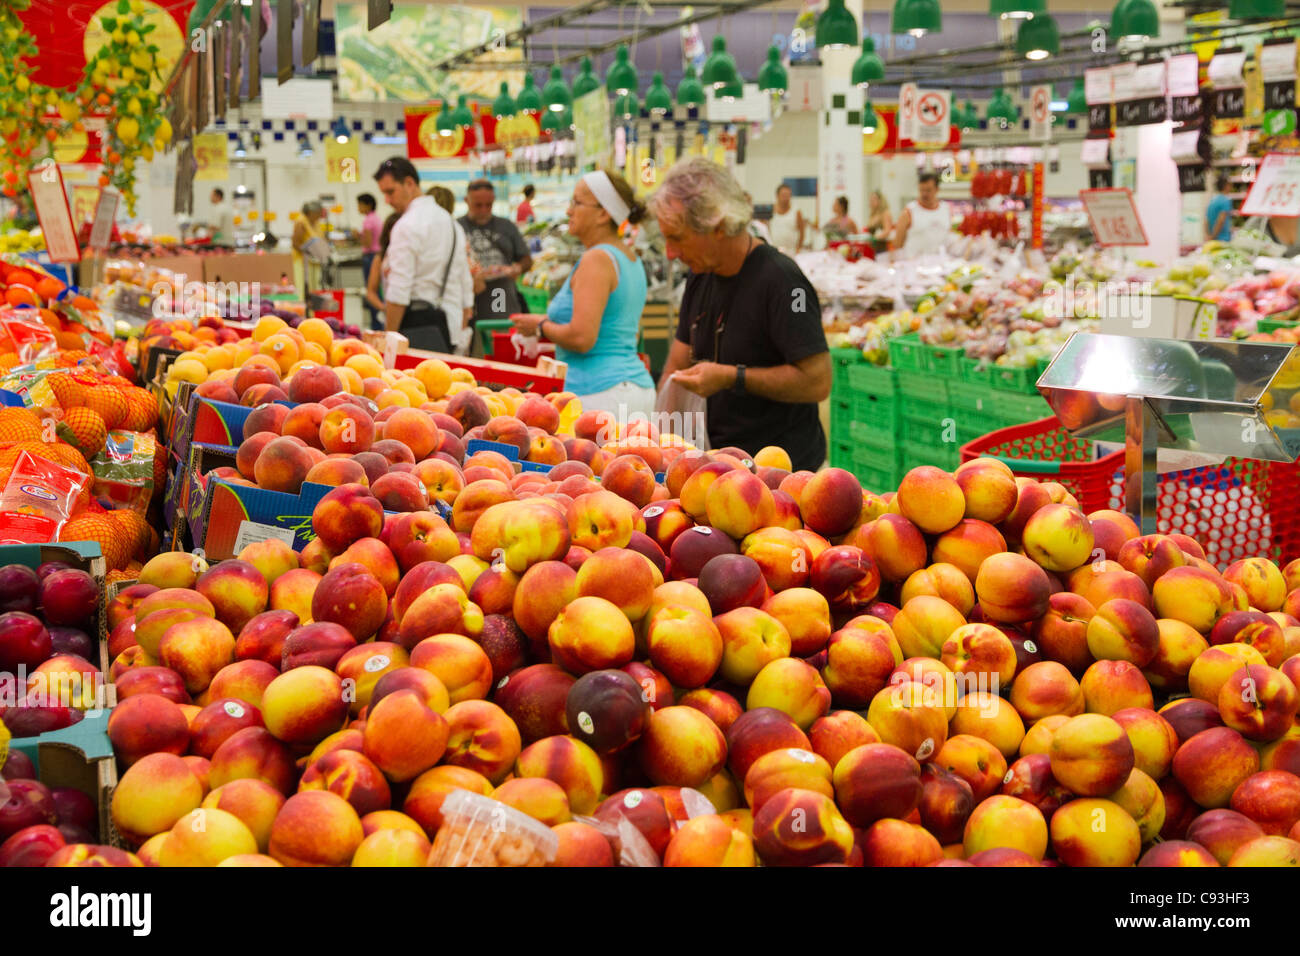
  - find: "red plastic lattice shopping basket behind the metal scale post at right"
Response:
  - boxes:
[962,418,1300,567]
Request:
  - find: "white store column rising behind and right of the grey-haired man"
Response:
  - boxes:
[816,0,867,240]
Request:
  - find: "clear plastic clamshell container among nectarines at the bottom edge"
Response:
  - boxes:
[429,790,560,866]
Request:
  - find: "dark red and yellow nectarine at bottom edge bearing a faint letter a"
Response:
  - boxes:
[753,785,861,866]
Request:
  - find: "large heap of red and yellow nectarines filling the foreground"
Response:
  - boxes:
[10,403,1300,866]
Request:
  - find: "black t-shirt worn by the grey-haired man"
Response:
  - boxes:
[677,242,827,471]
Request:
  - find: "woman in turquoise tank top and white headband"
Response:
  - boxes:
[514,170,655,421]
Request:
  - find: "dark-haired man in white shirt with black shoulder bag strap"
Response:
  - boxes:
[374,156,468,352]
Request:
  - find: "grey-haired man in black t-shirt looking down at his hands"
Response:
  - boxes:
[650,157,831,471]
